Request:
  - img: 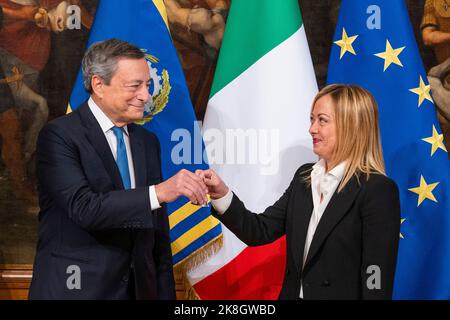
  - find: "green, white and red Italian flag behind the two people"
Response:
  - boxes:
[187,0,317,299]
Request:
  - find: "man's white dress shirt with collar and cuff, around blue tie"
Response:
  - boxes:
[88,98,161,211]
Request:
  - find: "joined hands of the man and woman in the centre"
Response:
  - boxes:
[155,169,228,206]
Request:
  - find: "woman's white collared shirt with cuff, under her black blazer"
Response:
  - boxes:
[211,160,345,299]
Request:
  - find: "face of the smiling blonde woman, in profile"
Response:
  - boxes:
[309,95,337,164]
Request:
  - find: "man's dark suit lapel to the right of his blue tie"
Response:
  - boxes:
[128,123,147,187]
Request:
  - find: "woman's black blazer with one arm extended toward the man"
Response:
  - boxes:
[215,164,400,299]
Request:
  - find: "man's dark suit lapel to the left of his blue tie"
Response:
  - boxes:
[78,103,123,189]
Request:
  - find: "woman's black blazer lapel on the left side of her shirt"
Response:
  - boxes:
[292,182,313,272]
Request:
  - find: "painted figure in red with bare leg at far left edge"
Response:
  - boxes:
[0,0,68,161]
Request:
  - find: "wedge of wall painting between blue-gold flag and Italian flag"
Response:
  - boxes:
[164,0,230,120]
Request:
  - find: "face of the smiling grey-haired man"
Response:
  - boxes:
[99,59,151,126]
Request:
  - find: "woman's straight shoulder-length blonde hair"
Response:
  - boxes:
[305,84,386,192]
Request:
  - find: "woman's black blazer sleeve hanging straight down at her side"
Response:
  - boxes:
[361,176,400,299]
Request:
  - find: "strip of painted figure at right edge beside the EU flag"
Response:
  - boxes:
[420,0,450,149]
